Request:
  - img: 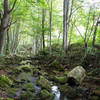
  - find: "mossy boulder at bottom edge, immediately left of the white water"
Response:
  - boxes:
[40,89,54,100]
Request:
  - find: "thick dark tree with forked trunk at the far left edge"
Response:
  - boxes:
[0,0,17,54]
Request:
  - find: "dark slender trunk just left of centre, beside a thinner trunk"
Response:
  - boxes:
[42,8,45,48]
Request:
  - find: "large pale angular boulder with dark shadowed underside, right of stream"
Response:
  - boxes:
[67,66,86,85]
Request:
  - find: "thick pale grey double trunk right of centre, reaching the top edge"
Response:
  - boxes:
[63,0,69,51]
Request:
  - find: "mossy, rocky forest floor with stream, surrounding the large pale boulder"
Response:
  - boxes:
[0,44,100,100]
